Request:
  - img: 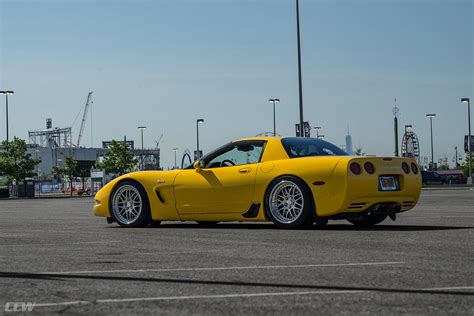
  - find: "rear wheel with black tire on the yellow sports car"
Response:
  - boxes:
[265,176,315,229]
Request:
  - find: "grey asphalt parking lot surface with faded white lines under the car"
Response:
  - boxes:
[0,188,474,315]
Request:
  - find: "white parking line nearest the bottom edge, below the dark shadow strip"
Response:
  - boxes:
[35,290,367,307]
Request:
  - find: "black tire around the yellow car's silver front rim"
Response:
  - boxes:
[109,181,150,227]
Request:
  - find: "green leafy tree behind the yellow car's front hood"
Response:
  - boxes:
[96,140,137,175]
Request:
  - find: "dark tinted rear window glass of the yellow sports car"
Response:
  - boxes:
[281,137,347,158]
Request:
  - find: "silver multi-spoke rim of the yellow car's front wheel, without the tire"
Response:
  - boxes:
[112,184,143,225]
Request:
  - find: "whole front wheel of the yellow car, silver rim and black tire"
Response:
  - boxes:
[110,181,150,227]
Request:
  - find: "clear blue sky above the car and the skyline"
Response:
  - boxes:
[0,0,474,168]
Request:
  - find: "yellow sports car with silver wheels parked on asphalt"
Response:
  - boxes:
[94,137,421,228]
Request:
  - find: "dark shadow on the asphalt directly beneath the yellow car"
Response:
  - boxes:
[110,222,474,231]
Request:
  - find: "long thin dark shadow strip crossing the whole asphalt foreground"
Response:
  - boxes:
[0,272,474,296]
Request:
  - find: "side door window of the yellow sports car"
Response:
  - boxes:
[206,142,265,168]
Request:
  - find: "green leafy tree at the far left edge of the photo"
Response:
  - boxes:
[0,137,41,183]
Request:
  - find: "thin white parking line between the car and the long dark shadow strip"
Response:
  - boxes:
[38,261,406,275]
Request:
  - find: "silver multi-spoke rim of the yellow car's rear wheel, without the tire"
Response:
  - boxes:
[269,180,304,224]
